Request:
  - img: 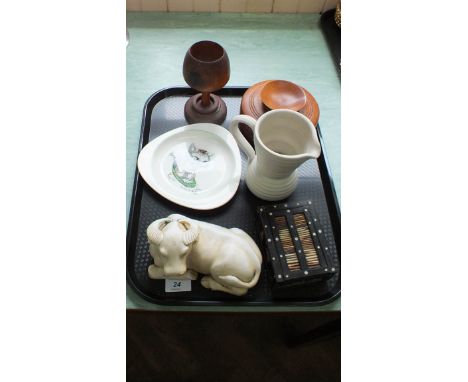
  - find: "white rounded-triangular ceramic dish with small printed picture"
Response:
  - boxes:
[138,123,241,210]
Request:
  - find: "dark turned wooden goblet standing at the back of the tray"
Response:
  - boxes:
[183,41,231,124]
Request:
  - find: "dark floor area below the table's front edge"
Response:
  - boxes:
[127,311,340,382]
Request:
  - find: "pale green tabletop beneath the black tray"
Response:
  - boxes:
[126,12,341,312]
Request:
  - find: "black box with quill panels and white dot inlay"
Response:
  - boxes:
[257,201,338,290]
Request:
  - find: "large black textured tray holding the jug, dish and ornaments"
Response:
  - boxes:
[127,87,341,306]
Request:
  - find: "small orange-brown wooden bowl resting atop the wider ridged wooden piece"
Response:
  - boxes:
[260,80,307,111]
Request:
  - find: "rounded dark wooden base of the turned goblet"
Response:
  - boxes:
[184,93,227,125]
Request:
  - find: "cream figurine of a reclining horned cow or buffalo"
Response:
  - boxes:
[146,214,262,296]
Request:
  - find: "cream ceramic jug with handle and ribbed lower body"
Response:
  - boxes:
[229,109,321,201]
